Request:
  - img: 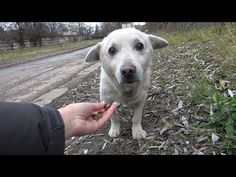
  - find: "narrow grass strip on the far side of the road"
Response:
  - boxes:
[0,40,99,65]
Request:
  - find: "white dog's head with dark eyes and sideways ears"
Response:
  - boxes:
[85,28,168,85]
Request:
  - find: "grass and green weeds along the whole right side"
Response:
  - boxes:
[159,23,236,154]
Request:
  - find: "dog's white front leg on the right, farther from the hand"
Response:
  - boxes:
[132,101,146,139]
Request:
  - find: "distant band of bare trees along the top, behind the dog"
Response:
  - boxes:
[0,22,229,50]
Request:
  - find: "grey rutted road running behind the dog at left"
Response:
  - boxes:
[0,47,99,105]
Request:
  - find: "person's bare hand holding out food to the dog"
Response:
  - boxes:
[58,102,118,139]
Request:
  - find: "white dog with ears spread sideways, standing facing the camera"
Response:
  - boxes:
[85,28,168,139]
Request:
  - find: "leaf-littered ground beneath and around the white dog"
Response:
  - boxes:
[48,37,235,155]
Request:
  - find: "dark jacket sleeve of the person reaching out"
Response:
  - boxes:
[0,102,65,155]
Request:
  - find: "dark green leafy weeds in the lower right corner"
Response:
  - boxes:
[200,93,236,154]
